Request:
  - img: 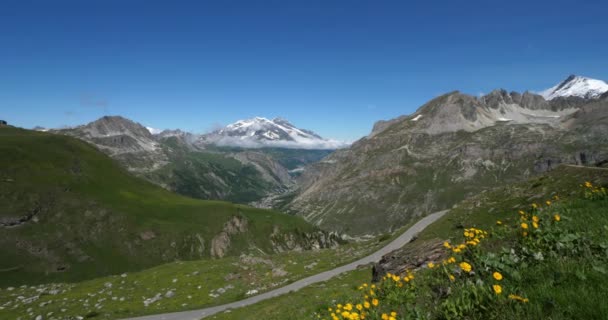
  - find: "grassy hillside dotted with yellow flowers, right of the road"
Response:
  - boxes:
[211,167,608,319]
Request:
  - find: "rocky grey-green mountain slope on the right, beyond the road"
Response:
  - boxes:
[285,90,608,235]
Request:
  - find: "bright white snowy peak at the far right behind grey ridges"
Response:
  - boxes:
[539,75,608,100]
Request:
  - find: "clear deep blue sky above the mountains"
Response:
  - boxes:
[0,0,608,140]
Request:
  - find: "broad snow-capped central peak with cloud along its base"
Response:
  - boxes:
[204,117,347,149]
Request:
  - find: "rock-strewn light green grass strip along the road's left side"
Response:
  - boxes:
[0,232,388,319]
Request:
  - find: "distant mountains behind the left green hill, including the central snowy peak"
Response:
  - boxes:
[51,116,340,203]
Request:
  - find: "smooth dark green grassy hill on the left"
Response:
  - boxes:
[0,127,324,285]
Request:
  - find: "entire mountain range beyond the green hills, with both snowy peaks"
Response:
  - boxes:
[34,76,608,236]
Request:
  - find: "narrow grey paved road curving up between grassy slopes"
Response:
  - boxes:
[124,210,447,320]
